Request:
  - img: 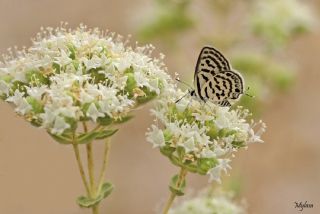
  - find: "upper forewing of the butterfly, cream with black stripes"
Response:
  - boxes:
[194,46,231,100]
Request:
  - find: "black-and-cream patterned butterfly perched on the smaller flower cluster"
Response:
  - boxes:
[189,46,244,106]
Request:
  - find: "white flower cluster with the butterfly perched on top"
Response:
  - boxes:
[147,90,265,182]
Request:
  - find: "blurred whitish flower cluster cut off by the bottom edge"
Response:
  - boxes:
[169,188,247,214]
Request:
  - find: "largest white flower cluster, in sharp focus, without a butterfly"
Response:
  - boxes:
[0,25,172,135]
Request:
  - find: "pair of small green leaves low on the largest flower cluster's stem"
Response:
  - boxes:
[77,182,114,208]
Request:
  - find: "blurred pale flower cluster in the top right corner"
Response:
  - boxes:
[251,0,314,46]
